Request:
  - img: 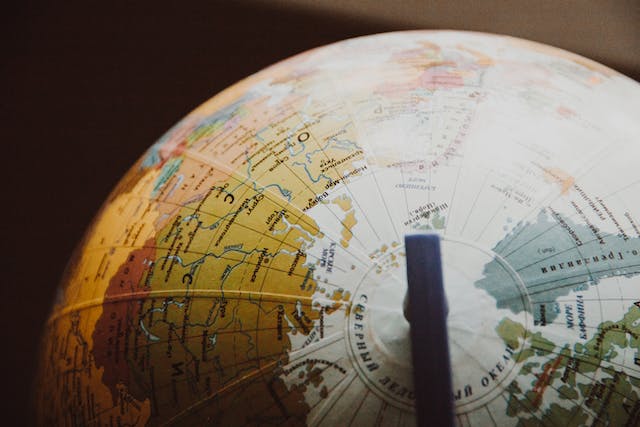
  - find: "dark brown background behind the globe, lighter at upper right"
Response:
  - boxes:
[0,0,640,425]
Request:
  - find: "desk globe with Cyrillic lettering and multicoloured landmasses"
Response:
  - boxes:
[36,31,640,426]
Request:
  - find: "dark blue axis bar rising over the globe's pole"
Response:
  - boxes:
[405,234,454,427]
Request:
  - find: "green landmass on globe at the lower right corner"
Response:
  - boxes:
[496,306,640,426]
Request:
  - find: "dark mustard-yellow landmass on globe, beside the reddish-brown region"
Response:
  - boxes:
[115,156,330,425]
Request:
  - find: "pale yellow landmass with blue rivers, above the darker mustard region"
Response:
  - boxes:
[187,94,364,216]
